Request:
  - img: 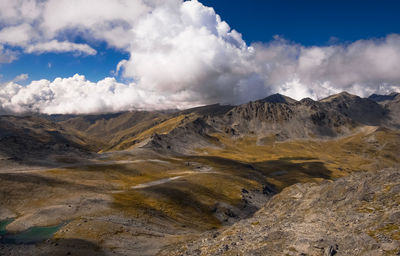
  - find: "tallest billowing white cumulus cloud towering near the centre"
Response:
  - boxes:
[120,1,262,103]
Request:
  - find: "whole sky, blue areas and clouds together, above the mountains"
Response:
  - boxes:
[0,0,400,114]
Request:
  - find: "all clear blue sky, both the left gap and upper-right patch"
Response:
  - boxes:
[0,0,400,84]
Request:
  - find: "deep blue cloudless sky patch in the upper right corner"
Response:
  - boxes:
[202,0,400,46]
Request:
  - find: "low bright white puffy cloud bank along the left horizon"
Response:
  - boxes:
[0,74,200,114]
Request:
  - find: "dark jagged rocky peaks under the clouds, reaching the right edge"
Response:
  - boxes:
[196,92,400,144]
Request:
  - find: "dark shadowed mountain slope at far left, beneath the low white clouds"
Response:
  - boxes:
[0,116,101,161]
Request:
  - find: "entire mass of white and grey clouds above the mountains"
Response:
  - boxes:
[0,0,400,114]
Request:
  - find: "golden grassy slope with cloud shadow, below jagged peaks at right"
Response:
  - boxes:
[198,127,400,191]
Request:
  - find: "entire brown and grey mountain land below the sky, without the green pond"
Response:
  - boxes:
[0,92,400,255]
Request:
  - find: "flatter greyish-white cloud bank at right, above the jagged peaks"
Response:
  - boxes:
[254,34,400,99]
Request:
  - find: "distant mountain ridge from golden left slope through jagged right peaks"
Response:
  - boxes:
[25,92,400,155]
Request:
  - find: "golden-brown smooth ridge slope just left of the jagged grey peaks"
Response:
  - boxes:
[56,110,214,152]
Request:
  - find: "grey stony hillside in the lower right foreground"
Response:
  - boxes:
[162,169,400,255]
